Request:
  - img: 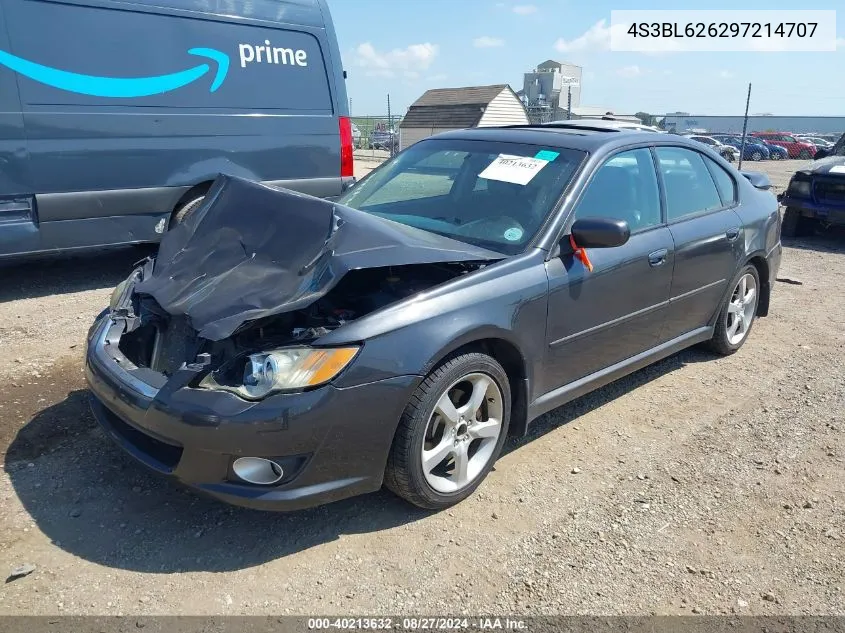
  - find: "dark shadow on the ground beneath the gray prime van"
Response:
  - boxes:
[0,245,156,303]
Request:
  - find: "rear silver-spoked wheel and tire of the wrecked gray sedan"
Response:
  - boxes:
[708,264,761,356]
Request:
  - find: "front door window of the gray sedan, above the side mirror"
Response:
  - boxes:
[575,148,661,232]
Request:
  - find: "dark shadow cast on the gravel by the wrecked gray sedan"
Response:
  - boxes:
[6,350,712,573]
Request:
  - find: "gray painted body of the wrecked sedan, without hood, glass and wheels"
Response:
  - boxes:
[82,127,781,509]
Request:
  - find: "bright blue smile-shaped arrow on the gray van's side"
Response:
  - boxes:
[0,48,229,99]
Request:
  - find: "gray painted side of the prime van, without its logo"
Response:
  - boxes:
[0,0,348,258]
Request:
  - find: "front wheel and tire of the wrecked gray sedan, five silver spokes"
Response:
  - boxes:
[384,353,511,510]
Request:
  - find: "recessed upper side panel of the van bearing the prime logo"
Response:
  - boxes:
[0,0,333,114]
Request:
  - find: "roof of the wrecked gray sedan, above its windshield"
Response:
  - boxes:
[429,123,701,153]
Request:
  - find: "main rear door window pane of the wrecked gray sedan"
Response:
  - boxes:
[656,147,722,222]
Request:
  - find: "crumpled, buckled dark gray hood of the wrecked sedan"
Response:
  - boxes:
[135,174,504,340]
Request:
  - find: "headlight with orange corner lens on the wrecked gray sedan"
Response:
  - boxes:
[200,347,359,400]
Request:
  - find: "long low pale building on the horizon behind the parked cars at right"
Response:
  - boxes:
[663,112,845,134]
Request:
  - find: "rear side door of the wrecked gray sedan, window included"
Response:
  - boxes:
[655,146,744,340]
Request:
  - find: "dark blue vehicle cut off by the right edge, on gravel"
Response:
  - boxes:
[778,134,845,237]
